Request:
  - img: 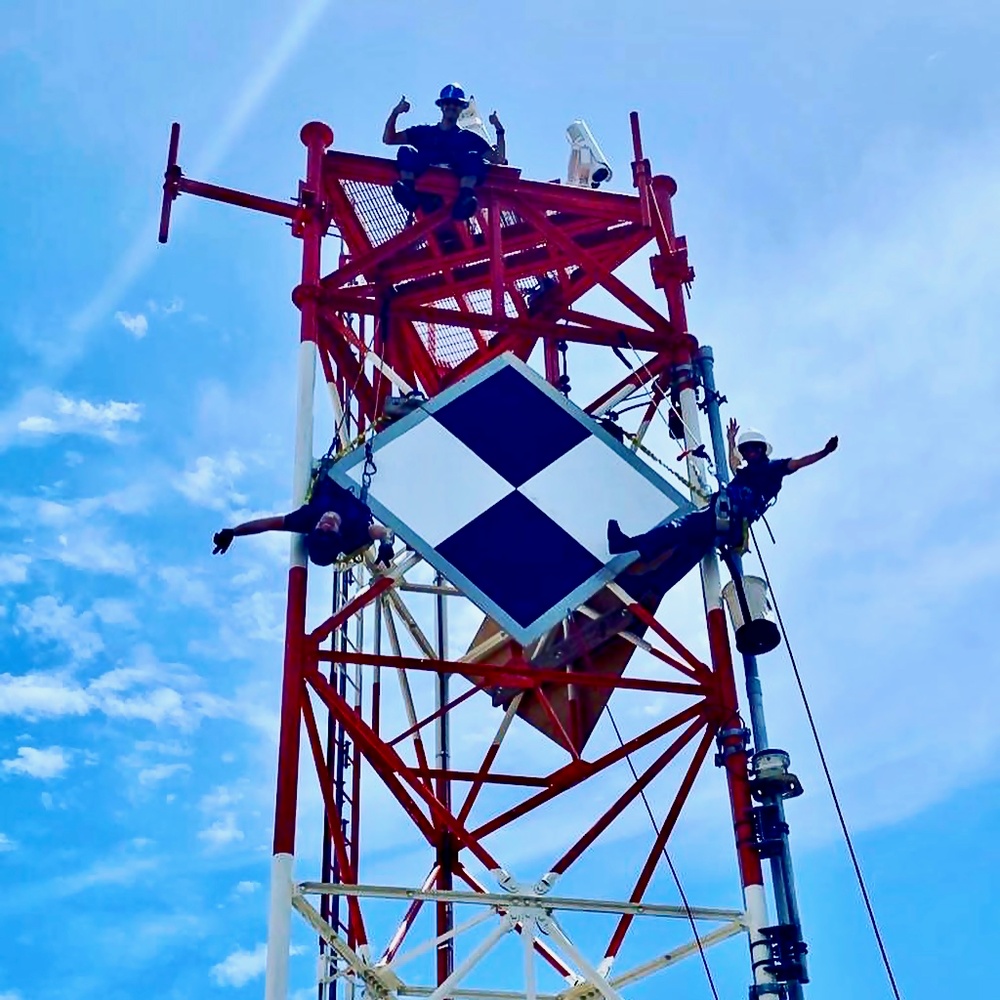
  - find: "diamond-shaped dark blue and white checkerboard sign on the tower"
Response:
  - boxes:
[330,354,692,643]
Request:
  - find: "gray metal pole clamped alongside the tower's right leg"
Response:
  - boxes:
[695,346,805,1000]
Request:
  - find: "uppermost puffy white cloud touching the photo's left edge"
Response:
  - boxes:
[0,389,142,443]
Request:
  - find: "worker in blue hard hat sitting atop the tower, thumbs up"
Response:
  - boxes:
[382,83,507,219]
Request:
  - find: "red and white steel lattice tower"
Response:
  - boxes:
[160,114,804,1000]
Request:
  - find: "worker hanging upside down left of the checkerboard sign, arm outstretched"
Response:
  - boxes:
[212,475,392,566]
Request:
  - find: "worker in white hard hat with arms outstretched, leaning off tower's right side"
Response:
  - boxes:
[608,420,838,586]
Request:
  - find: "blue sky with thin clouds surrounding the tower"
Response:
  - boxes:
[0,0,1000,1000]
